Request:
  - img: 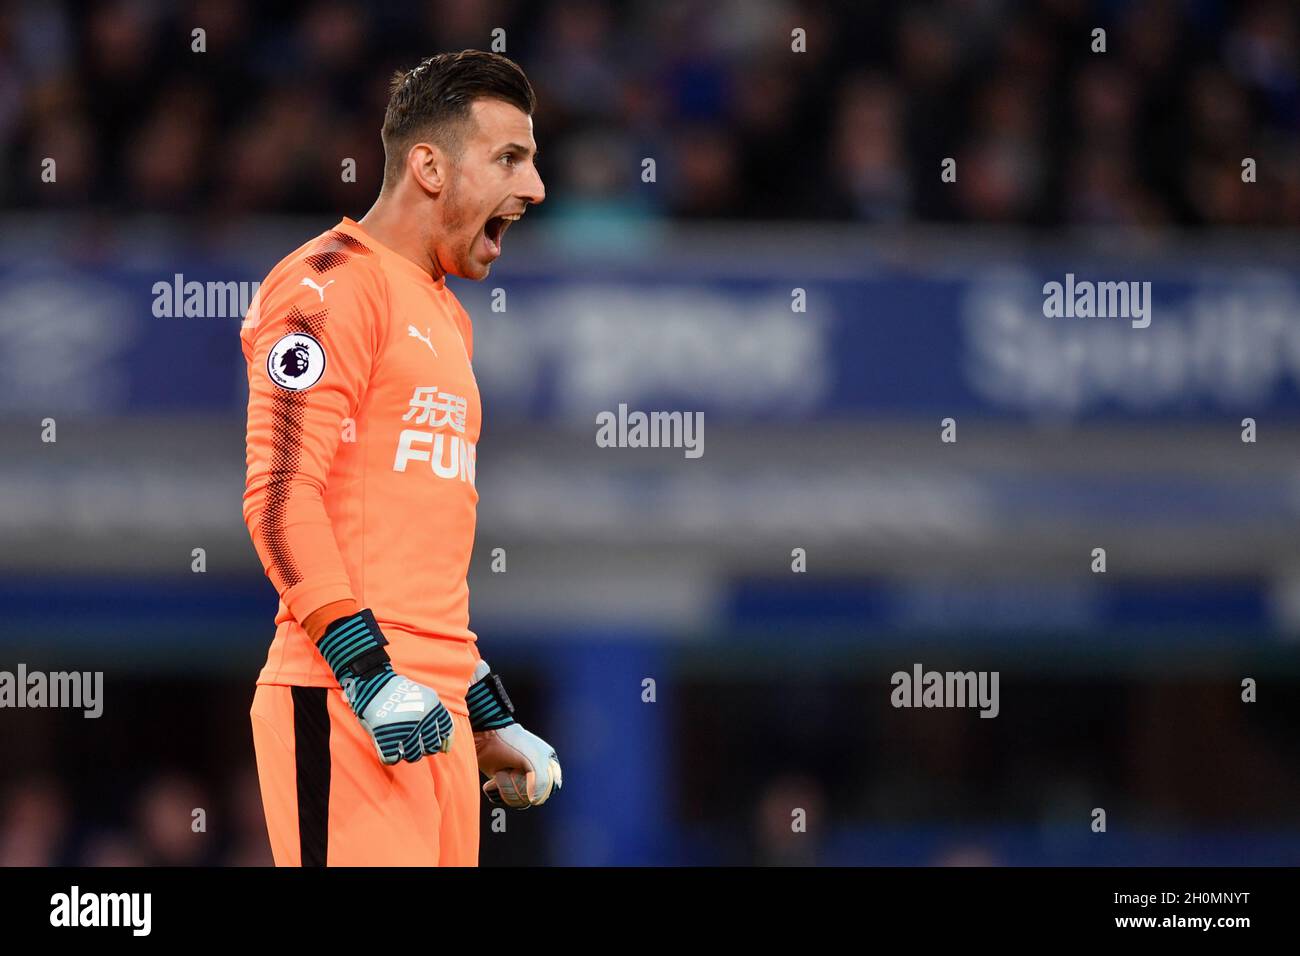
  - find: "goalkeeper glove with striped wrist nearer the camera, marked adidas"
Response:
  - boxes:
[317,607,451,763]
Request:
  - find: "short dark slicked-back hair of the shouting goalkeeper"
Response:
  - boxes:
[381,49,537,185]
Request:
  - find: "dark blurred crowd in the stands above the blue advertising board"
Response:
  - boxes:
[0,0,1300,228]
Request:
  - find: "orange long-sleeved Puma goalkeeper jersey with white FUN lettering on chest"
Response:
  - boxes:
[241,219,481,714]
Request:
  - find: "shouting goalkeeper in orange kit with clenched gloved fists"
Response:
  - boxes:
[241,51,562,866]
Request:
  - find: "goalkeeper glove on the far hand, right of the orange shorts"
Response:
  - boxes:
[465,661,562,810]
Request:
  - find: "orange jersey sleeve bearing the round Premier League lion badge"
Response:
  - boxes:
[242,256,386,637]
